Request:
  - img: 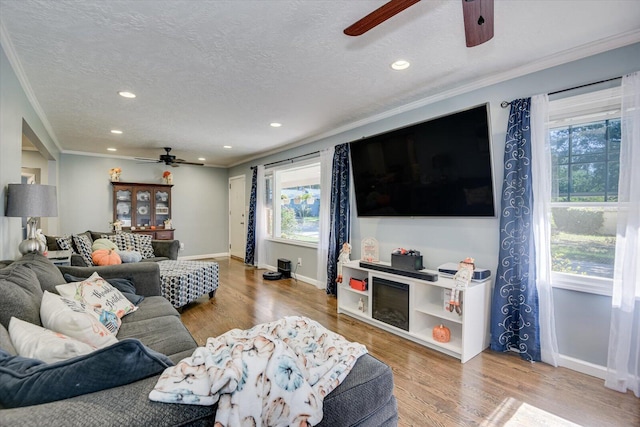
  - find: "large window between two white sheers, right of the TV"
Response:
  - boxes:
[549,87,621,293]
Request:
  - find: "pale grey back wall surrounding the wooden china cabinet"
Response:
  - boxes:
[58,154,229,257]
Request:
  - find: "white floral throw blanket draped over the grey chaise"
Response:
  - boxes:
[149,316,367,427]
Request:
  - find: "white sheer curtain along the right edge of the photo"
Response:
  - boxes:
[605,72,640,397]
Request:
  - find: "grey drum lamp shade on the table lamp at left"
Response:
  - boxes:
[7,184,58,218]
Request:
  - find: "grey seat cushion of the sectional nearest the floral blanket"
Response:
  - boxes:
[118,313,196,356]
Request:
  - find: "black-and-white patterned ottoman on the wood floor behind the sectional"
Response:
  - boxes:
[158,260,218,308]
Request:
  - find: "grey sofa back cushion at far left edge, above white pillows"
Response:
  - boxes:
[0,264,42,328]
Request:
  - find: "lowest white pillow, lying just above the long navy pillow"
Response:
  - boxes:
[9,317,95,363]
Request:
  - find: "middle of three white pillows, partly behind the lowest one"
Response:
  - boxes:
[40,291,118,348]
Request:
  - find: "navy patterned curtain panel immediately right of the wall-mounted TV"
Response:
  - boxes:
[491,98,540,361]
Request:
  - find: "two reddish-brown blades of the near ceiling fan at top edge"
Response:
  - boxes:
[344,0,493,47]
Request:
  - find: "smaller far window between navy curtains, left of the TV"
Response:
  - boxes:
[265,160,320,245]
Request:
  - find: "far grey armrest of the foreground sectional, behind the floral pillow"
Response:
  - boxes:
[58,262,162,296]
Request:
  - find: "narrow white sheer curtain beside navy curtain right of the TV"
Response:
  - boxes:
[531,94,558,366]
